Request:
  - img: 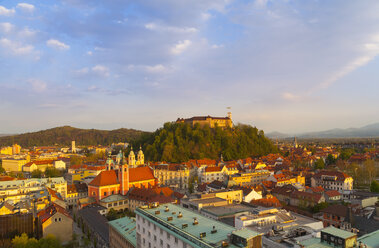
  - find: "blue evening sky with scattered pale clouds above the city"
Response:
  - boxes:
[0,0,379,133]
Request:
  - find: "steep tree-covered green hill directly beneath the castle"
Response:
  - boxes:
[134,123,277,162]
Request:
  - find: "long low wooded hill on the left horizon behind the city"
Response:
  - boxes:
[0,126,144,147]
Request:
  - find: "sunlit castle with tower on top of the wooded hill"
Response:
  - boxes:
[176,112,233,128]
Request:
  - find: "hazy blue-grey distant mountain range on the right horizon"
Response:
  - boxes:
[266,123,379,139]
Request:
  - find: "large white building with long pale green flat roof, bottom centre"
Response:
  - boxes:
[135,204,262,248]
